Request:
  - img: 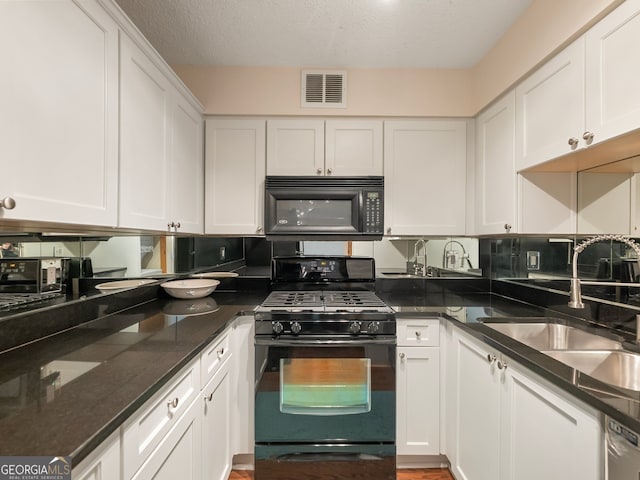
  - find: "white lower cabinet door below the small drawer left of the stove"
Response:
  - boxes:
[202,354,232,480]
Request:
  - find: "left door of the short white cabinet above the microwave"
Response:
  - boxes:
[267,119,325,176]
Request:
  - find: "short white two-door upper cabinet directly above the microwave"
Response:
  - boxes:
[267,119,382,176]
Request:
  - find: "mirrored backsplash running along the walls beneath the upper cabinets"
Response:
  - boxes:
[0,234,640,307]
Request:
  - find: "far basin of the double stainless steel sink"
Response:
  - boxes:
[485,323,622,350]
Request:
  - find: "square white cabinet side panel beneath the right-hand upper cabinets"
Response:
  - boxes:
[517,172,577,235]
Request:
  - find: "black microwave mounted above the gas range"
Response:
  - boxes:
[264,176,384,240]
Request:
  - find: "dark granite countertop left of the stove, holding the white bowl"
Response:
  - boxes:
[0,293,265,465]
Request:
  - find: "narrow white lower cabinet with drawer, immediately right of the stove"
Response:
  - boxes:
[396,318,440,455]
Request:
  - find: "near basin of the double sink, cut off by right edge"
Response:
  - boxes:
[542,350,640,391]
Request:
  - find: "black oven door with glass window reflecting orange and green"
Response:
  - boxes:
[255,338,396,444]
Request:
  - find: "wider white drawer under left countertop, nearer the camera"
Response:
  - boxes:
[122,359,200,478]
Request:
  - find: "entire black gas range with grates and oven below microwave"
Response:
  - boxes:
[254,257,396,480]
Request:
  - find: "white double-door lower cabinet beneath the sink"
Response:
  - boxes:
[447,332,604,480]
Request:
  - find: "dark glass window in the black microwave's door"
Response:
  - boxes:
[276,199,353,227]
